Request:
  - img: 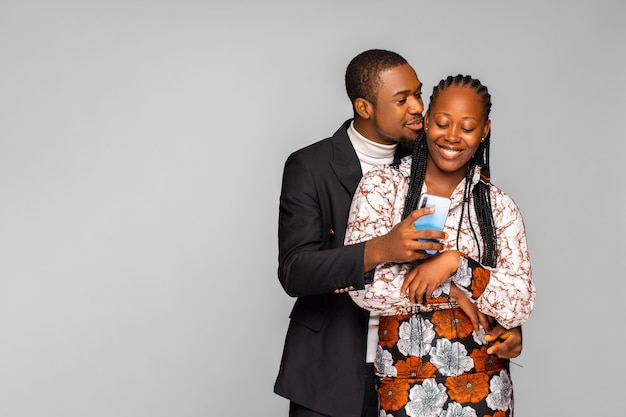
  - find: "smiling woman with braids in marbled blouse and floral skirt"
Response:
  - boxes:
[345,75,535,417]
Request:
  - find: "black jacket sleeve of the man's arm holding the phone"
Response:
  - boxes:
[278,153,365,297]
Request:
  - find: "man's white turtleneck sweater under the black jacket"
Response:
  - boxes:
[348,121,398,362]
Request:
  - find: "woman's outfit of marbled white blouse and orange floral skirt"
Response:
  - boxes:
[345,158,535,417]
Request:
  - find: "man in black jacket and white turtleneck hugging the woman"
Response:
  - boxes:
[274,49,521,417]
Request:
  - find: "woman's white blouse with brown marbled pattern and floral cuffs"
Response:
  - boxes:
[345,157,535,328]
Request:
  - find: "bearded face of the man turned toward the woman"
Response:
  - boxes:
[366,64,424,144]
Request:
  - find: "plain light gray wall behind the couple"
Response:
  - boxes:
[0,0,626,417]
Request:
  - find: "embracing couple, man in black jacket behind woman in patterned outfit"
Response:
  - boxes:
[274,50,535,417]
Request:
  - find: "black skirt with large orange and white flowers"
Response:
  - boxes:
[375,265,513,417]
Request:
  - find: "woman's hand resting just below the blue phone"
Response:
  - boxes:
[400,250,461,304]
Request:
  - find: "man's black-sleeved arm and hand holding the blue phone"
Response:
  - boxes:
[278,154,446,296]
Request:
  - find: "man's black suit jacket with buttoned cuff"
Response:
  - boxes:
[274,120,369,417]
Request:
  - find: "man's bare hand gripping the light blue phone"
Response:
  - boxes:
[363,207,447,272]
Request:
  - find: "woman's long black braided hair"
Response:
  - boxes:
[402,74,497,267]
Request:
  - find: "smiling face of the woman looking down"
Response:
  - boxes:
[424,86,491,178]
